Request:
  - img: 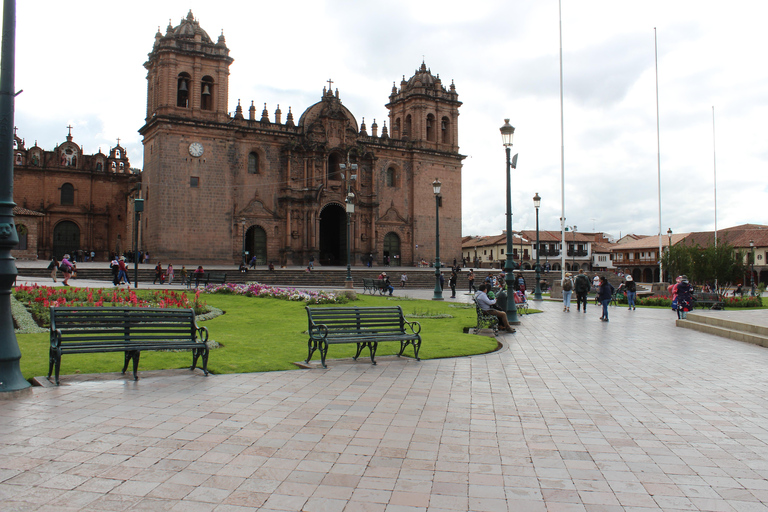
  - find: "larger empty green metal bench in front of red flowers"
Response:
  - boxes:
[48,307,208,385]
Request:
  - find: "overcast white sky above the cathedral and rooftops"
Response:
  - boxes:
[4,0,768,237]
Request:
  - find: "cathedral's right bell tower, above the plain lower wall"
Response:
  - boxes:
[386,62,461,153]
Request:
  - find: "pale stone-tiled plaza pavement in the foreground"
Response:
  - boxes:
[0,291,768,512]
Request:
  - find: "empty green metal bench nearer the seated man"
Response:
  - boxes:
[305,306,421,368]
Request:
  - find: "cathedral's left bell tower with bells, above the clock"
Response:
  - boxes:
[144,11,234,123]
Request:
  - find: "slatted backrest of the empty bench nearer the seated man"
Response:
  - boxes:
[306,306,412,334]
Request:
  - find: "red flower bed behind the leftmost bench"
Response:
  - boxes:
[14,285,210,327]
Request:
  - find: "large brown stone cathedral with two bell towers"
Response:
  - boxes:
[139,12,464,266]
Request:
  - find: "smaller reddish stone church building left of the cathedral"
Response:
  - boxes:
[13,128,140,261]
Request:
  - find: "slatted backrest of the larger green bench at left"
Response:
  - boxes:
[51,307,197,343]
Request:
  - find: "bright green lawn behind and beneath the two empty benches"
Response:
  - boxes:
[16,294,497,378]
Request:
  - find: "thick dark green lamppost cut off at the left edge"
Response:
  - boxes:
[0,0,30,392]
